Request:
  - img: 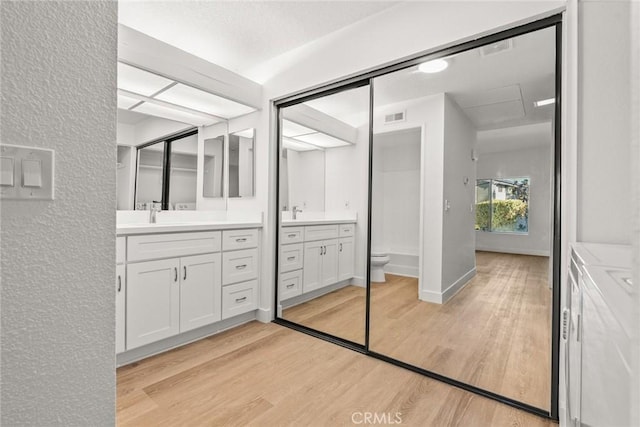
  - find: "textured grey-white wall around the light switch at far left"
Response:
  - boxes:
[0,1,117,426]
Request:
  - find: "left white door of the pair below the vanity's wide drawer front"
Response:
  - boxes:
[127,258,180,350]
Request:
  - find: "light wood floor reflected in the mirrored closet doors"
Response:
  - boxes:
[284,252,551,409]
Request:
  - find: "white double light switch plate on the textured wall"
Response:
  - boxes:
[0,144,55,200]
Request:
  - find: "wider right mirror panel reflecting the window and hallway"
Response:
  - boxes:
[369,28,556,410]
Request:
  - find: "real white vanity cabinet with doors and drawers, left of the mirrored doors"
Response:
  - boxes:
[116,228,259,353]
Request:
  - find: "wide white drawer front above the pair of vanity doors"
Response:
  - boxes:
[127,231,221,261]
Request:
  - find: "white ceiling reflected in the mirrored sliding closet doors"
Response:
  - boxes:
[298,23,555,139]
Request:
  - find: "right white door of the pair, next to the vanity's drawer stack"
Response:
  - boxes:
[180,253,222,332]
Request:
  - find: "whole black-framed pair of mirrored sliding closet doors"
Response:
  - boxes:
[276,15,560,419]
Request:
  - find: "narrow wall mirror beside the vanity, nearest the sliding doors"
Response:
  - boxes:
[229,129,255,197]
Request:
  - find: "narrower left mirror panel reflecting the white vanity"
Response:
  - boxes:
[278,86,369,345]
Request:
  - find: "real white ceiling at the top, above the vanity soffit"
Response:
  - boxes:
[118,0,397,75]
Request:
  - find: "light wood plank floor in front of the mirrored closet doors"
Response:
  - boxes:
[117,322,554,427]
